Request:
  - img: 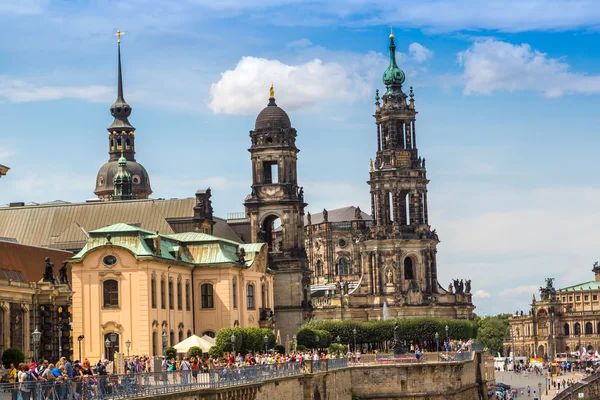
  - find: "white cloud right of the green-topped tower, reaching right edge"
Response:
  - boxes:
[458,40,600,97]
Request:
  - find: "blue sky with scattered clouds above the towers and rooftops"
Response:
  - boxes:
[0,0,600,314]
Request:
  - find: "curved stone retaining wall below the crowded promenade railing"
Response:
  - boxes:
[141,353,493,400]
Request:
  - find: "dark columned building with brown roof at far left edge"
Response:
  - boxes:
[0,238,73,360]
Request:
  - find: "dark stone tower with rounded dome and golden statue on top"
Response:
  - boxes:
[244,86,311,341]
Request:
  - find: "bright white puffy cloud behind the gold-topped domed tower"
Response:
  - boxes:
[209,57,371,114]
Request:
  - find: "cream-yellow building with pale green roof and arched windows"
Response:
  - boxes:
[70,224,274,360]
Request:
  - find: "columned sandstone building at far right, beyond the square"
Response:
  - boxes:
[504,263,600,357]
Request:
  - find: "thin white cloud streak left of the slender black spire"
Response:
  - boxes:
[0,78,115,103]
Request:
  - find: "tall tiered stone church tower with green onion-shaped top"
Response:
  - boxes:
[363,30,439,296]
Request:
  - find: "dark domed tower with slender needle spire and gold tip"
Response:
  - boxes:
[94,31,152,200]
